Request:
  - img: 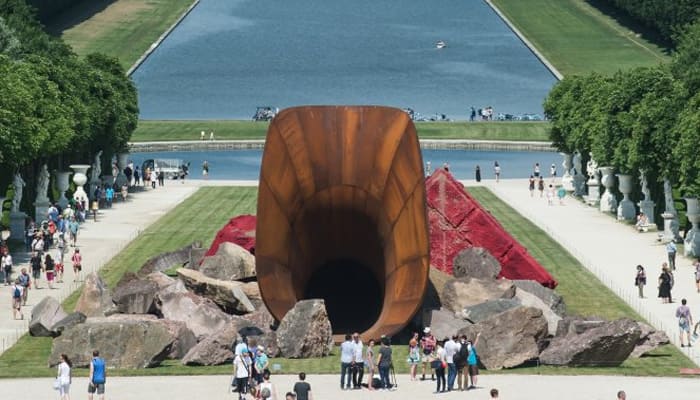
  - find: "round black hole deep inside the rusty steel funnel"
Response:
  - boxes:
[304,259,384,334]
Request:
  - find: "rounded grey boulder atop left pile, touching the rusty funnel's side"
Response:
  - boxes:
[197,242,255,281]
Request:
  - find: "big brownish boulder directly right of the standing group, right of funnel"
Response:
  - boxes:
[459,306,547,370]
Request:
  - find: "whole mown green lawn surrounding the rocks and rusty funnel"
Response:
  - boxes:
[0,187,692,378]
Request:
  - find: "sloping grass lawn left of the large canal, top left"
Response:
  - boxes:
[47,0,193,69]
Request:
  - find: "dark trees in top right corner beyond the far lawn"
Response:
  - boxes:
[605,0,700,43]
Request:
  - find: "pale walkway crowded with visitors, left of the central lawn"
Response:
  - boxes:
[0,181,205,354]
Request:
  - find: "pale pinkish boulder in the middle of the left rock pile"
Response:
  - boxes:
[157,292,231,340]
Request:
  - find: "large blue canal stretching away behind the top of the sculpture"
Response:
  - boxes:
[132,0,556,119]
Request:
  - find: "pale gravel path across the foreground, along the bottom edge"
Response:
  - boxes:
[1,372,700,400]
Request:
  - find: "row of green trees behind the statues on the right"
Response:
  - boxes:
[544,21,700,217]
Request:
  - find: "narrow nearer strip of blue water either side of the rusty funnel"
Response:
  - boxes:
[130,150,561,180]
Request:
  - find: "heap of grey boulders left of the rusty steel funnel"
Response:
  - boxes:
[45,239,332,368]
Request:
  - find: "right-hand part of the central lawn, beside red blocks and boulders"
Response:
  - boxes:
[468,187,694,376]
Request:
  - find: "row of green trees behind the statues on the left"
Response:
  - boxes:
[0,0,138,219]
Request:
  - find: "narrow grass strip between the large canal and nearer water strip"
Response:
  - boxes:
[131,120,549,142]
